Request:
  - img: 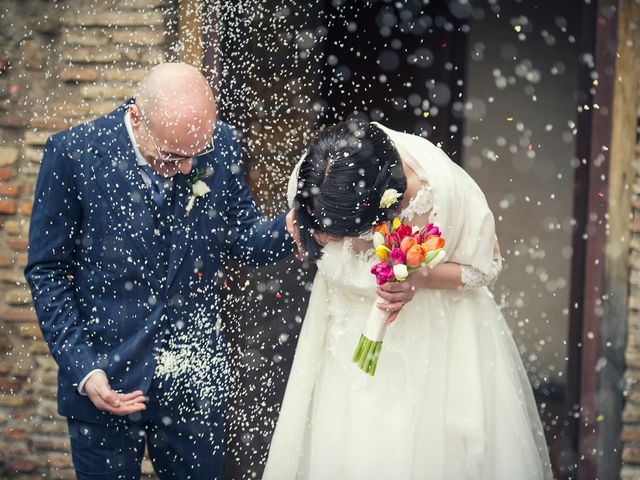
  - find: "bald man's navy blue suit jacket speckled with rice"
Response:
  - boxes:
[25,100,294,478]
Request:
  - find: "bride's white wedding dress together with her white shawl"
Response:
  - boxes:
[263,125,552,480]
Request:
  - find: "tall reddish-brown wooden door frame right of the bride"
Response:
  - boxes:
[567,0,640,480]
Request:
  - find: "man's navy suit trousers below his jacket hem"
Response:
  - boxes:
[68,379,224,480]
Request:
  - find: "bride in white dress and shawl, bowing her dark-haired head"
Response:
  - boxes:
[263,121,552,480]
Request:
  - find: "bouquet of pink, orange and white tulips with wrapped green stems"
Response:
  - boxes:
[353,218,446,376]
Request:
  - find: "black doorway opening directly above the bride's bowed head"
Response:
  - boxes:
[322,0,471,163]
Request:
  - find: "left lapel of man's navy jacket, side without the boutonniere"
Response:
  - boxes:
[92,116,162,278]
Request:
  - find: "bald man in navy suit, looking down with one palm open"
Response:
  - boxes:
[25,64,294,480]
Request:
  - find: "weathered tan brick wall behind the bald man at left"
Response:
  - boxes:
[0,0,176,479]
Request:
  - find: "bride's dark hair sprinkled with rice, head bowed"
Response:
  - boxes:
[294,120,407,260]
